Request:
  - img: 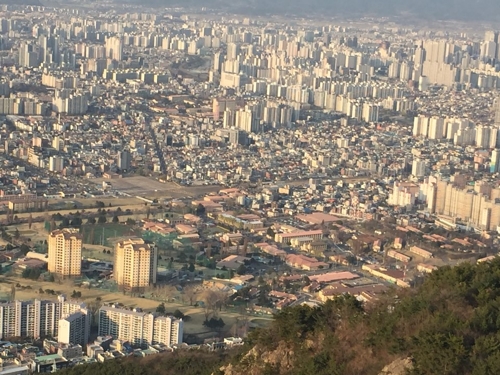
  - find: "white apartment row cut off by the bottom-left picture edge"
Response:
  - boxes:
[0,295,90,345]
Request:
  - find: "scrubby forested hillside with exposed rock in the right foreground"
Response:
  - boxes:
[62,260,500,375]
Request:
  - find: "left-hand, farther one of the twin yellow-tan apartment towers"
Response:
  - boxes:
[48,228,82,276]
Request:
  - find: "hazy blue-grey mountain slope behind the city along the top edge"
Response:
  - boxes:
[116,0,500,21]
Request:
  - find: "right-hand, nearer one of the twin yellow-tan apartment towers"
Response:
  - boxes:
[113,238,158,291]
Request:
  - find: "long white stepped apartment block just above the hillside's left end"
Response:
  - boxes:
[99,305,184,346]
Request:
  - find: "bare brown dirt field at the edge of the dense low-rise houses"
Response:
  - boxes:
[96,176,221,198]
